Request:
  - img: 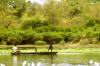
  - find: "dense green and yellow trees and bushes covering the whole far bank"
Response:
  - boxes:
[0,0,100,45]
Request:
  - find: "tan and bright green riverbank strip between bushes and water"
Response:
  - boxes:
[0,44,100,54]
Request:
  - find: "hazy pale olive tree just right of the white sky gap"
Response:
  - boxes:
[43,1,61,25]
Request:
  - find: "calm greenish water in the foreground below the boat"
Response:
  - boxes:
[0,53,100,66]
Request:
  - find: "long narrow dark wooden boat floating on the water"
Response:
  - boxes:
[11,52,57,55]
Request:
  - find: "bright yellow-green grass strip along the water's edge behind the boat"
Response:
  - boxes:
[0,48,100,54]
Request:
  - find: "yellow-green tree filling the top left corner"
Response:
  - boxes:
[0,0,26,28]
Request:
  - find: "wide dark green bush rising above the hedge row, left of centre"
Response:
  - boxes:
[21,17,48,29]
